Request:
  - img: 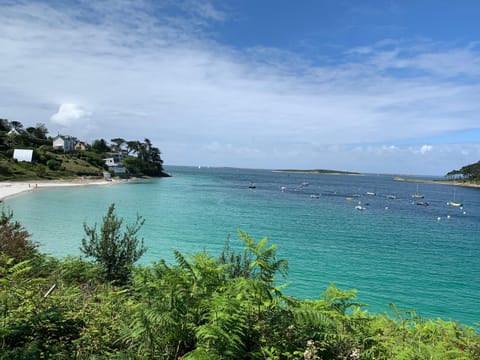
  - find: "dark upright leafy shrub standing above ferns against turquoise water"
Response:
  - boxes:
[80,204,147,285]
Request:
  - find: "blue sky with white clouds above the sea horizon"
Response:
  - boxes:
[0,0,480,175]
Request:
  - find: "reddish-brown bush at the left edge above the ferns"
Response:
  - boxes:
[0,210,38,261]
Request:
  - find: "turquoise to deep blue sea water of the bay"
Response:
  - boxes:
[3,167,480,325]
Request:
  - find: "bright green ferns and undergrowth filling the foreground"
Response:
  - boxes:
[0,206,480,360]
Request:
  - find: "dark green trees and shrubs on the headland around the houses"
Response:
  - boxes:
[0,119,167,181]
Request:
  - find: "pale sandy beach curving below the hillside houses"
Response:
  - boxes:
[0,178,126,200]
